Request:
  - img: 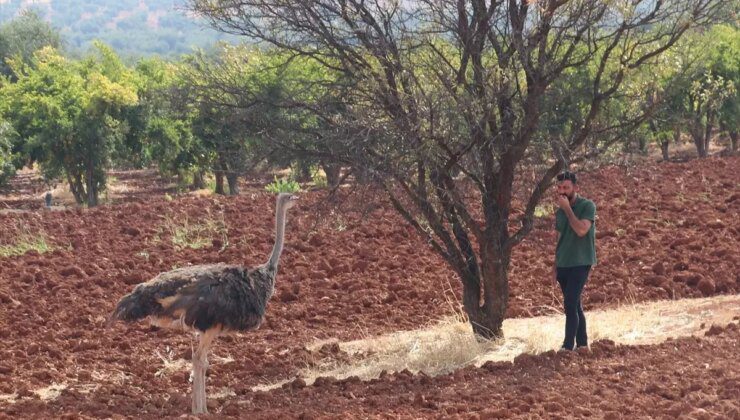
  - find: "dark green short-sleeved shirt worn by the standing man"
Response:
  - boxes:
[555,197,596,267]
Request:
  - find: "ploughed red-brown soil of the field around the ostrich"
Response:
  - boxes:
[0,158,740,418]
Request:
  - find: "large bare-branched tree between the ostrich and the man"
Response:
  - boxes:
[189,0,722,338]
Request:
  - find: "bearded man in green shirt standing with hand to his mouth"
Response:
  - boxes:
[553,171,596,350]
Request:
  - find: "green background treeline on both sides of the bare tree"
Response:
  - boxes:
[0,10,740,206]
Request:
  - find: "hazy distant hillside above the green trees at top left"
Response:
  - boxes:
[0,0,238,56]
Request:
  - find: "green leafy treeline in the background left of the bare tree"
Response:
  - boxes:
[0,10,332,206]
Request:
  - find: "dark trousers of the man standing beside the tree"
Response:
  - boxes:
[557,265,591,350]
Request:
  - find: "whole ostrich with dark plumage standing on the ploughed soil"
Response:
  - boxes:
[109,193,298,414]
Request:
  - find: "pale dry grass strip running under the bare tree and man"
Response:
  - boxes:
[254,295,740,390]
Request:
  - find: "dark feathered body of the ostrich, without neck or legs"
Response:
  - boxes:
[111,264,266,331]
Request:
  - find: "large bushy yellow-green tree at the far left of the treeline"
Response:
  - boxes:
[0,44,138,206]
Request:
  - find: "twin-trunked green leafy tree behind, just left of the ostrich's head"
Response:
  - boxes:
[183,44,290,195]
